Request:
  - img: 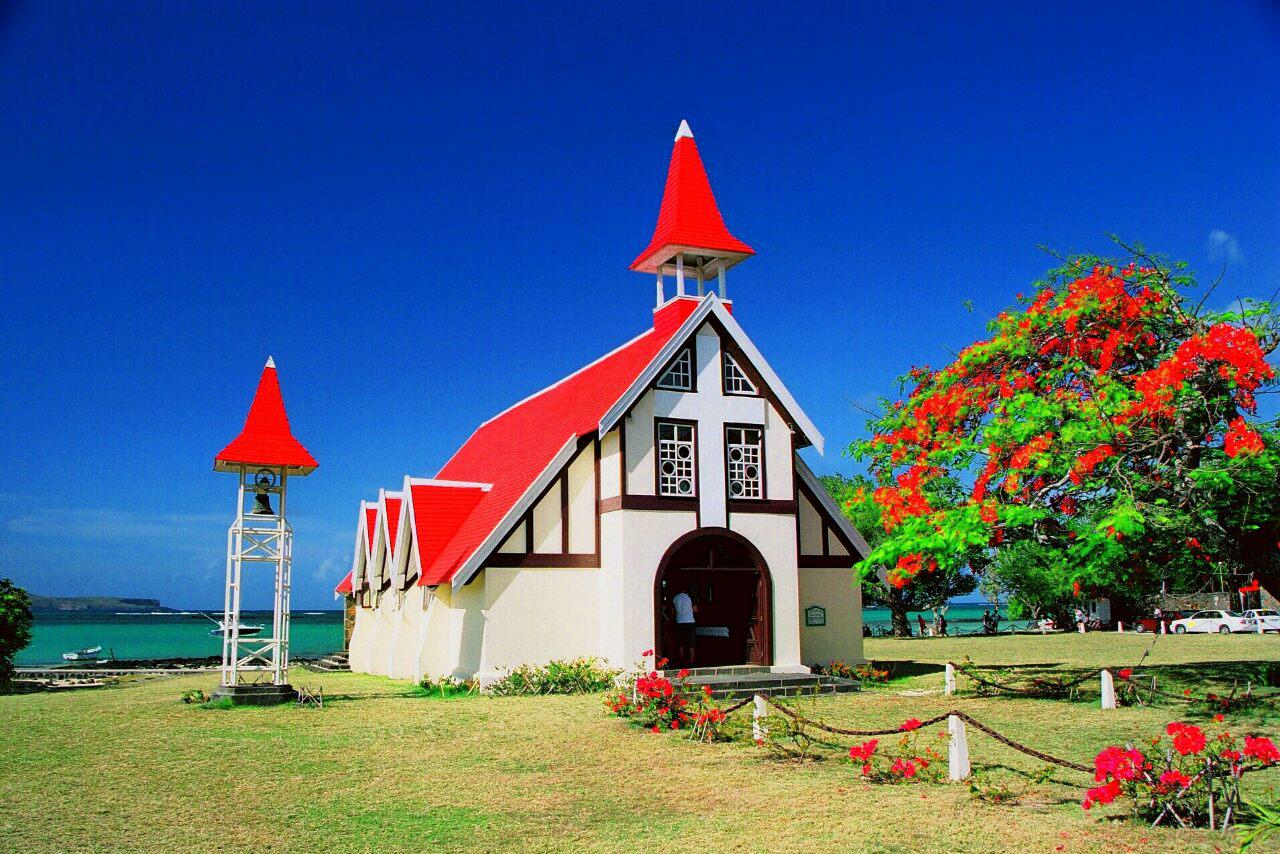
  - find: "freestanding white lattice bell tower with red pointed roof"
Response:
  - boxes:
[214,357,320,705]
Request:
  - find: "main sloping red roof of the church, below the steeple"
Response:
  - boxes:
[413,313,696,586]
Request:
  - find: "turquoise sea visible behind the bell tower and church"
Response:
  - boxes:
[18,604,1010,665]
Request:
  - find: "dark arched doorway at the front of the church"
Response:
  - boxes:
[653,528,773,667]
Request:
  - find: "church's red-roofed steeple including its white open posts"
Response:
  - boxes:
[631,122,755,306]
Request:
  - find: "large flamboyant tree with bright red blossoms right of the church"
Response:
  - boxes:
[849,247,1280,595]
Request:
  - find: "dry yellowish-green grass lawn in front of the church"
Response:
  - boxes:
[0,634,1280,851]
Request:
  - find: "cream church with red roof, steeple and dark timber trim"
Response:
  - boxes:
[337,123,867,680]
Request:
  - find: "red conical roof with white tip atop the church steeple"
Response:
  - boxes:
[631,122,755,273]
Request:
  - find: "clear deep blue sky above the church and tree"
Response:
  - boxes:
[0,1,1280,607]
